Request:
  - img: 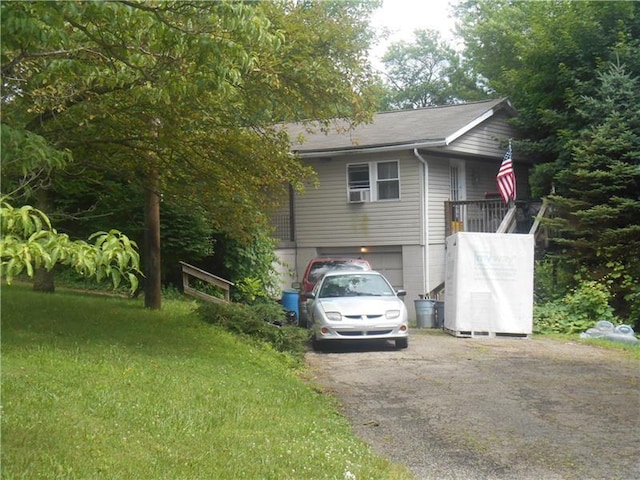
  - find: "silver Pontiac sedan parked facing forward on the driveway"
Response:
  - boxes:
[307,271,409,349]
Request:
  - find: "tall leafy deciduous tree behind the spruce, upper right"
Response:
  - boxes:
[455,0,640,165]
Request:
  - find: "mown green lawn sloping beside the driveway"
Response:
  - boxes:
[1,285,411,480]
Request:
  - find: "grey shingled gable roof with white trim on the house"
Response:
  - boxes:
[287,98,515,157]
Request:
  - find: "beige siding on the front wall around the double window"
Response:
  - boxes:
[295,152,420,247]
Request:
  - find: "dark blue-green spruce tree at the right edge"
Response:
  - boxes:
[550,65,640,314]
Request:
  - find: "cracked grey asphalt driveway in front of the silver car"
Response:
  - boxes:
[307,330,640,480]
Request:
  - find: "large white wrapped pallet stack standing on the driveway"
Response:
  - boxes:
[444,232,535,337]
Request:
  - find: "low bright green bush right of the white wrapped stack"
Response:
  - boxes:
[533,281,617,334]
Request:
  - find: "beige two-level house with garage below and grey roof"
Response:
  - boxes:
[275,99,531,318]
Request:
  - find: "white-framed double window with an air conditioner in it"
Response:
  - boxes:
[347,161,400,203]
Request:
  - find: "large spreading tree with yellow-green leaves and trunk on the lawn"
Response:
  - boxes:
[1,0,376,308]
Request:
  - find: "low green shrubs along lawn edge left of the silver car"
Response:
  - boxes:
[199,301,309,358]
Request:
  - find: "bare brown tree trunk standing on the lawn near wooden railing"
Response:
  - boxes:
[144,168,162,310]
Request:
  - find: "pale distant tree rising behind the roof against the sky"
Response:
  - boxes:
[382,30,487,109]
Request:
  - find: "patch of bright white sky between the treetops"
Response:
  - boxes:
[371,0,456,68]
